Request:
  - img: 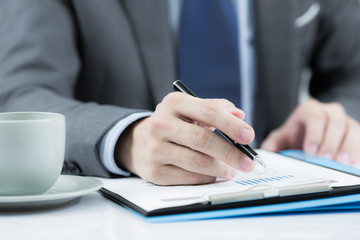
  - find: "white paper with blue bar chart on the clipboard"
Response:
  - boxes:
[101,150,360,221]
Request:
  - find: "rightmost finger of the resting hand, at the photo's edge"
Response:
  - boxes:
[335,118,360,165]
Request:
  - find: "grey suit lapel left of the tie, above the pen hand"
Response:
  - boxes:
[123,0,176,103]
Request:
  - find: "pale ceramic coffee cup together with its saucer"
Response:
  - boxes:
[0,112,103,211]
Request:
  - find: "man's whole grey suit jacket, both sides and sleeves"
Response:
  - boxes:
[0,0,360,177]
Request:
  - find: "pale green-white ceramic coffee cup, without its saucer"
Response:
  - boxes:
[0,112,65,196]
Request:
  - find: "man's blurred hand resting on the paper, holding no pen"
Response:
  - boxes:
[261,99,360,164]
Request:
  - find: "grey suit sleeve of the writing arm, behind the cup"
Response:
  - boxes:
[0,0,136,177]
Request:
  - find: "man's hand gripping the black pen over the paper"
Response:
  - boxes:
[115,93,255,185]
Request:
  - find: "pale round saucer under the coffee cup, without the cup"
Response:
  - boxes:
[0,175,103,210]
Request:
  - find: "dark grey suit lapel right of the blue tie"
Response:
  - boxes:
[253,0,298,137]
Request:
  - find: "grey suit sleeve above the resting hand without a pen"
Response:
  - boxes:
[310,0,360,120]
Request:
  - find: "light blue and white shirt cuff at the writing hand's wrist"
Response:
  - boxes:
[100,112,153,176]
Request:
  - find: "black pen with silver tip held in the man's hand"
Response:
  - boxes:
[173,80,266,167]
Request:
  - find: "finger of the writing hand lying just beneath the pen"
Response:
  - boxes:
[167,119,255,172]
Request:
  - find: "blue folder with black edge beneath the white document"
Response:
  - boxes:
[100,150,360,223]
